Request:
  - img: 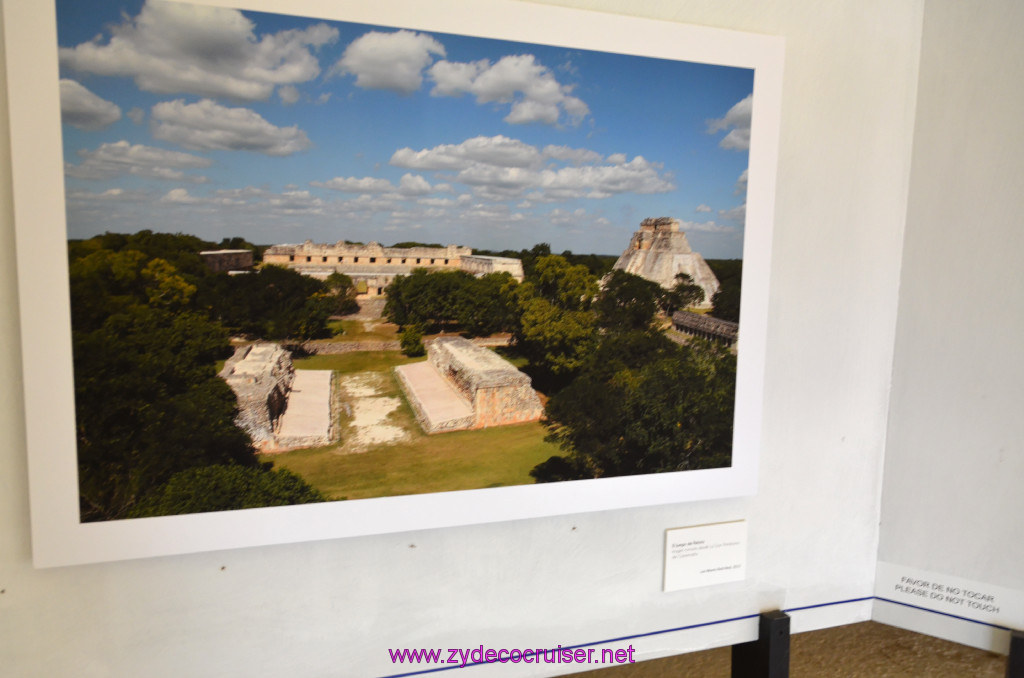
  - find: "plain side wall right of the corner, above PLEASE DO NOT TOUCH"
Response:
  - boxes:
[879,0,1024,643]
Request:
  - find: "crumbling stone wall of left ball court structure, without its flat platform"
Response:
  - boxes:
[220,344,295,447]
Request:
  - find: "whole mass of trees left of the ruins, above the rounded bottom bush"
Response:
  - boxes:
[69,230,335,521]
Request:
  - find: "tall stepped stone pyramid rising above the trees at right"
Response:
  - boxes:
[612,216,719,308]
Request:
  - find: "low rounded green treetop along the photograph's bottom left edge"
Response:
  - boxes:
[131,465,327,518]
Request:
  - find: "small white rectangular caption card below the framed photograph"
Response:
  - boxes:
[664,520,746,591]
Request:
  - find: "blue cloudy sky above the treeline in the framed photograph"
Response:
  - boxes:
[56,0,754,258]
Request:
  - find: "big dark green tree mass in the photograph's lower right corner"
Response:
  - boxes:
[532,332,735,481]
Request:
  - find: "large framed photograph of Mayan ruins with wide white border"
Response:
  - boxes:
[4,0,783,566]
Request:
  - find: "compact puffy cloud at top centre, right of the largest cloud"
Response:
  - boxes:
[331,31,444,94]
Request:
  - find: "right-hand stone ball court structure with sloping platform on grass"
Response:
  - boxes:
[395,337,544,433]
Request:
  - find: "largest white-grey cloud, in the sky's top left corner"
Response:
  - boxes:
[59,0,338,100]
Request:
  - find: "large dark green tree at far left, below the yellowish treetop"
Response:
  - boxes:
[73,305,256,520]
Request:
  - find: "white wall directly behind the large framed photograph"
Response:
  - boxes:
[0,0,923,677]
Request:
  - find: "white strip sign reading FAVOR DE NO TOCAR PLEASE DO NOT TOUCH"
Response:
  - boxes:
[874,562,1024,628]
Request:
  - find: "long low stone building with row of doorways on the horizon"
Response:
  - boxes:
[263,240,523,297]
